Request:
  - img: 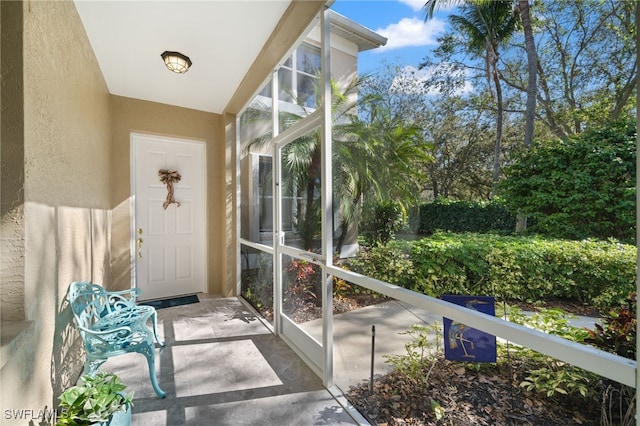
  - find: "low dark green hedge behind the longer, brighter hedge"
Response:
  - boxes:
[418,198,516,235]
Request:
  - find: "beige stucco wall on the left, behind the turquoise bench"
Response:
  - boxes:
[0,1,111,425]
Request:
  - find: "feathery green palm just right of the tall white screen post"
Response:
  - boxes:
[334,101,433,250]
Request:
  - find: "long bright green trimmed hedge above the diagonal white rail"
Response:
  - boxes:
[350,233,636,310]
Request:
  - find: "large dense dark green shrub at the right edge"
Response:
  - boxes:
[497,122,636,243]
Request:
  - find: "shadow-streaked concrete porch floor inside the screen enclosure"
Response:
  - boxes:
[102,295,356,426]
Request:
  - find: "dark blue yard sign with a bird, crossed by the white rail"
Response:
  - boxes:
[442,295,496,362]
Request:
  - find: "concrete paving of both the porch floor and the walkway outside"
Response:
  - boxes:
[95,296,597,426]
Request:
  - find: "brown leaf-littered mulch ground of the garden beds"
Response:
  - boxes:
[248,294,620,426]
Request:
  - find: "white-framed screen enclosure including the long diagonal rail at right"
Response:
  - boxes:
[237,5,640,412]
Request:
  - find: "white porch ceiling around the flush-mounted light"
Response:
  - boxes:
[75,0,290,113]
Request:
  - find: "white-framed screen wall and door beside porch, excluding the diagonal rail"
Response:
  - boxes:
[238,12,333,386]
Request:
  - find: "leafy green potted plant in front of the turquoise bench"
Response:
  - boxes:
[56,371,133,426]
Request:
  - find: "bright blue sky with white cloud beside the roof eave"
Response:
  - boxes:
[331,0,456,74]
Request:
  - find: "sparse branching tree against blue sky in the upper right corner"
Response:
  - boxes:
[503,0,638,138]
